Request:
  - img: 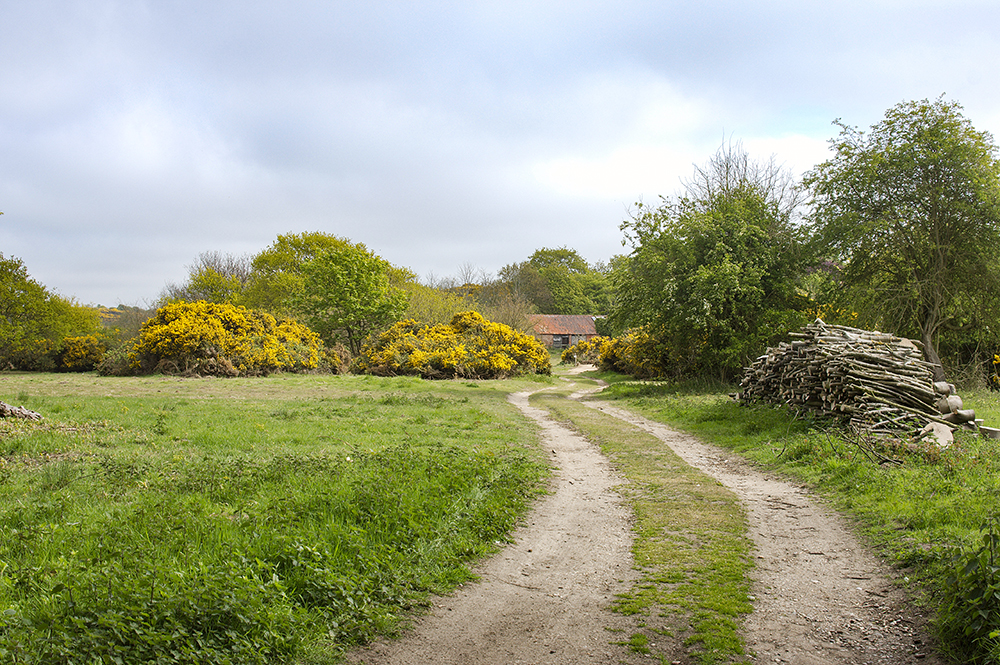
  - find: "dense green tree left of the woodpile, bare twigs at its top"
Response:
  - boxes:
[609,144,807,379]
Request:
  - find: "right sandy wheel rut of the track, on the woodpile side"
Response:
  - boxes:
[583,400,943,665]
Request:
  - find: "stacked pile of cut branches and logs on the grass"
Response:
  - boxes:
[739,319,975,434]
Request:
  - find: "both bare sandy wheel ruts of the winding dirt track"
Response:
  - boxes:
[348,374,941,665]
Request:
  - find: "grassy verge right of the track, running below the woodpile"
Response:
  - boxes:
[584,376,1000,662]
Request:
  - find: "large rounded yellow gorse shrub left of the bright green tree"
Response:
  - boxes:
[129,300,322,376]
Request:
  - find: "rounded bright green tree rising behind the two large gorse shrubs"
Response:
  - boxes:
[290,245,407,355]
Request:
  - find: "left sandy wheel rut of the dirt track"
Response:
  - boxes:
[348,386,648,665]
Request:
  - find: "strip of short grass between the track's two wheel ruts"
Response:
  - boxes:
[532,376,753,664]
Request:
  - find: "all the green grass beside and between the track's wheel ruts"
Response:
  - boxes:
[0,374,1000,665]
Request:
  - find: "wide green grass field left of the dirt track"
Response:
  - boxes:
[0,374,548,664]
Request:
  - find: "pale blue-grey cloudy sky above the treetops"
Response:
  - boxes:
[0,0,1000,305]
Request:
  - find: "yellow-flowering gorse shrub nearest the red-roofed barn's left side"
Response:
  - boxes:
[353,312,551,379]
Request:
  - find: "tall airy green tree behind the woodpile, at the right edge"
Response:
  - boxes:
[804,98,1000,380]
